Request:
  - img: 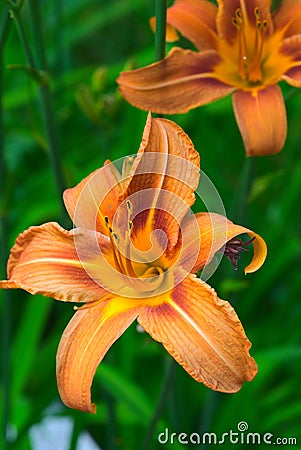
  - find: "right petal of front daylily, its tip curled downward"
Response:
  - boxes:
[181,213,267,273]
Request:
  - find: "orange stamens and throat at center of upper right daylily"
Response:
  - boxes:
[232,7,268,85]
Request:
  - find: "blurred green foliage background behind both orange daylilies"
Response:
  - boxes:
[0,0,301,450]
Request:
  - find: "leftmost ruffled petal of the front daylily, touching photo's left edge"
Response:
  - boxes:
[0,222,106,302]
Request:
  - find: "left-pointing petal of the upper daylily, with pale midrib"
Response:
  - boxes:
[117,48,233,114]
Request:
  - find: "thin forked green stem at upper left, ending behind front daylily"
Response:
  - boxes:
[7,0,69,226]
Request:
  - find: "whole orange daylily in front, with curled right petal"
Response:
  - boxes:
[0,115,266,413]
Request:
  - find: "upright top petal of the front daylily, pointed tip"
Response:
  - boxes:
[119,115,200,255]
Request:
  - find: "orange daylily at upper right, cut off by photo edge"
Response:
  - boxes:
[118,0,301,155]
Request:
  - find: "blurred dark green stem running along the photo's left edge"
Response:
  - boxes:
[0,15,11,450]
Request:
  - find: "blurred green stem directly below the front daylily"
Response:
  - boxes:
[141,357,175,450]
